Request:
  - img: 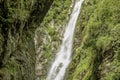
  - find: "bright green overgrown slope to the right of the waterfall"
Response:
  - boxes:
[66,0,120,80]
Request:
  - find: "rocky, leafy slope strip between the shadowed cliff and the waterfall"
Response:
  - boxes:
[35,0,72,80]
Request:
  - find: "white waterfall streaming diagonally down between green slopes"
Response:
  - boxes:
[46,0,83,80]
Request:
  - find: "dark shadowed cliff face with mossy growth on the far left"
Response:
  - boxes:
[0,0,53,80]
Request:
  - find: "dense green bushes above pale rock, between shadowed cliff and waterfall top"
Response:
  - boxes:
[42,0,71,27]
